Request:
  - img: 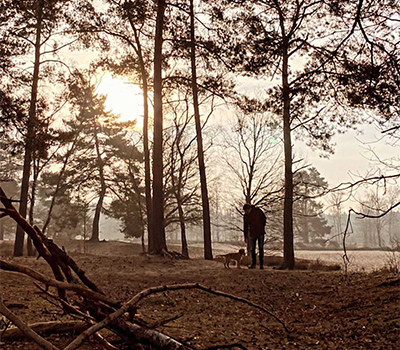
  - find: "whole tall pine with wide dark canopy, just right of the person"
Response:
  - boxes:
[205,0,398,269]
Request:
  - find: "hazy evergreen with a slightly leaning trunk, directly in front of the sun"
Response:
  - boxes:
[68,75,137,242]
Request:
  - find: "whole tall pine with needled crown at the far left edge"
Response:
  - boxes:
[0,0,92,256]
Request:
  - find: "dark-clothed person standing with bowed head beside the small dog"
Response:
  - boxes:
[243,204,267,270]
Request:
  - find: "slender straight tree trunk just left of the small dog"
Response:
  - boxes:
[190,0,213,260]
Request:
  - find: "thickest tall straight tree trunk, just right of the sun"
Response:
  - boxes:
[151,0,167,254]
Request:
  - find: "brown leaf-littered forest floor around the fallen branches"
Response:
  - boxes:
[0,242,399,350]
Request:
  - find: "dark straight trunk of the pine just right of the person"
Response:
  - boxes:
[282,43,295,269]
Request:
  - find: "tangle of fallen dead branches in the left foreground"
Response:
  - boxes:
[0,186,288,350]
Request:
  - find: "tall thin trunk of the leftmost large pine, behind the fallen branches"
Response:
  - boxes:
[14,0,44,256]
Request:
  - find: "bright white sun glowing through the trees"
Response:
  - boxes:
[96,74,143,128]
